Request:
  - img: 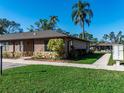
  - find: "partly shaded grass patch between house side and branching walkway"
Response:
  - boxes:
[71,53,103,64]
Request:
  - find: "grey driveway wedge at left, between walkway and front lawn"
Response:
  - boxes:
[3,62,26,69]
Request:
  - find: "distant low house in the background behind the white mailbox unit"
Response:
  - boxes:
[92,43,112,52]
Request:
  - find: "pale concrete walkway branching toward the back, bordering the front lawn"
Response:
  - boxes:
[3,54,124,71]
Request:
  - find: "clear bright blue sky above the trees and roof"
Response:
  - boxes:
[0,0,124,39]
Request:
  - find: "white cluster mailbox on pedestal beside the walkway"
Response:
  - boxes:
[113,44,124,66]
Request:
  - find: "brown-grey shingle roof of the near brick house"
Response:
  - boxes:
[0,30,87,41]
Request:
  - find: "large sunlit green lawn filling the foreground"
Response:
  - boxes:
[0,65,124,93]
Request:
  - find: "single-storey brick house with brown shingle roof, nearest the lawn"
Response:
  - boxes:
[0,31,90,56]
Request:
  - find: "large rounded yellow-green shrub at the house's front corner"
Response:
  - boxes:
[47,39,64,56]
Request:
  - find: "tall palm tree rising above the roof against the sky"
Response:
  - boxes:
[72,0,93,39]
